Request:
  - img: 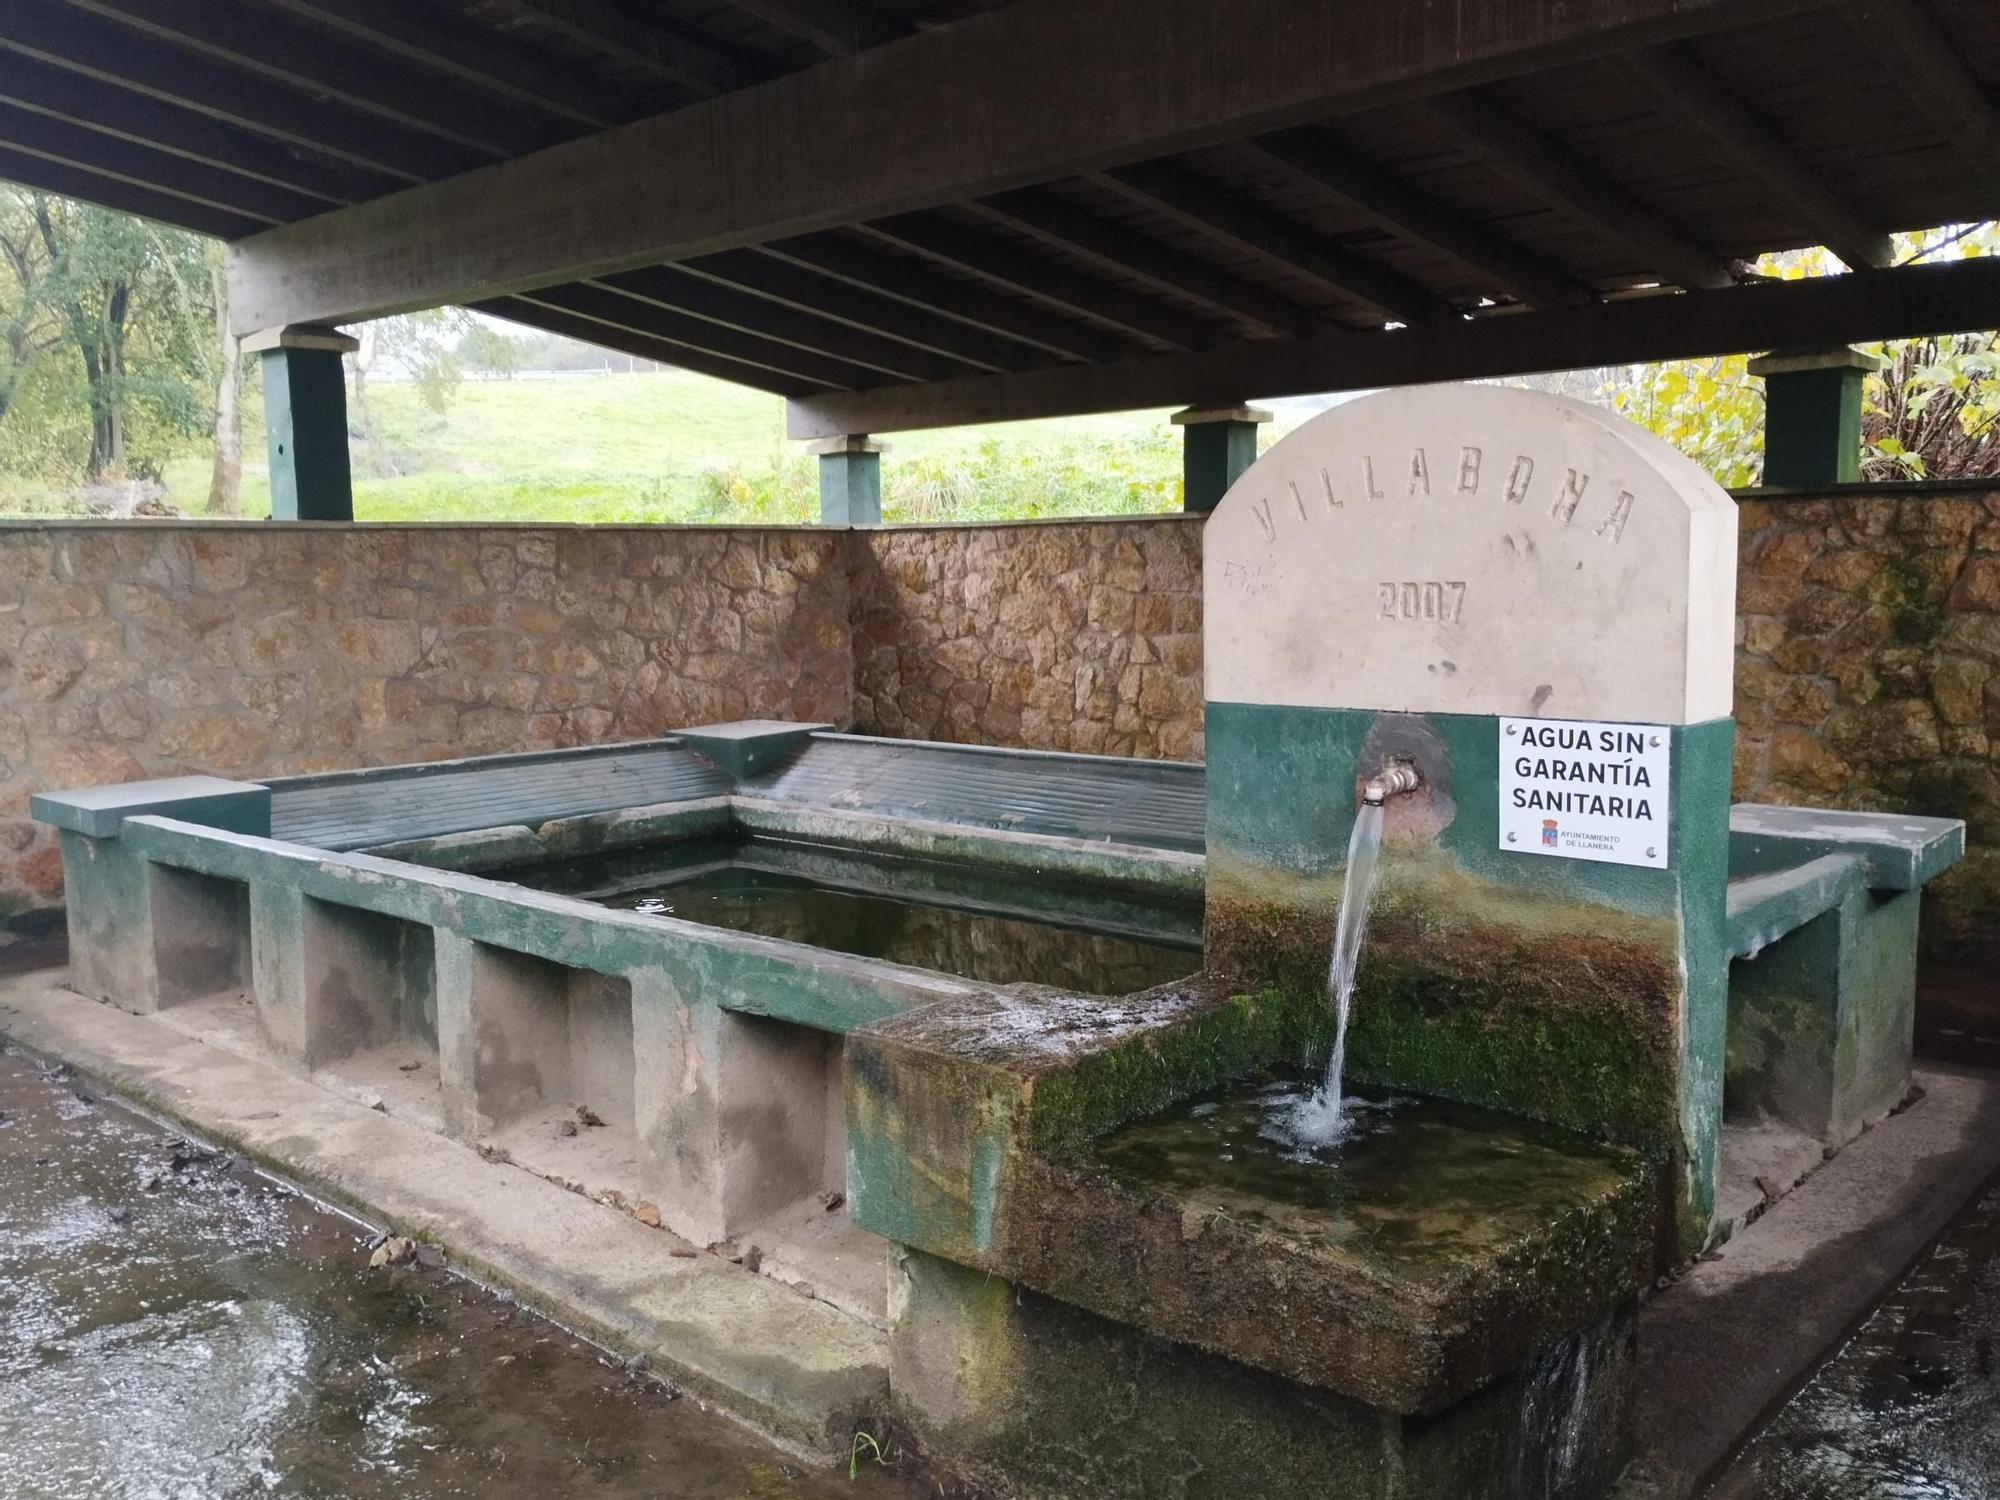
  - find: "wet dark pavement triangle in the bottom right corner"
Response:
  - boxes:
[1714,1178,2000,1500]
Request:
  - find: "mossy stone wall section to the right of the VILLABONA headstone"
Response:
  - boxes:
[1734,486,2000,962]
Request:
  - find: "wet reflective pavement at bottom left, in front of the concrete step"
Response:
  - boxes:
[0,1052,928,1500]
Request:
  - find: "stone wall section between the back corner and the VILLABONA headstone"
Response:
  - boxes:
[852,516,1202,760]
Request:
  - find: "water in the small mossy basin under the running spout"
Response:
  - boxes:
[1096,1078,1644,1278]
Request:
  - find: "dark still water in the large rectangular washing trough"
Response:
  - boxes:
[506,838,1202,994]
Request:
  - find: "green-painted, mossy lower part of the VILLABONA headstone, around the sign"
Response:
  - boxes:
[1208,704,1734,1252]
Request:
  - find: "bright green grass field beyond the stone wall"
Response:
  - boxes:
[0,370,1282,522]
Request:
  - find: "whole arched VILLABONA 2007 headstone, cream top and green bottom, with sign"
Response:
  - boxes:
[1204,386,1736,1248]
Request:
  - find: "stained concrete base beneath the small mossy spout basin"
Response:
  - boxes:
[890,1250,1634,1500]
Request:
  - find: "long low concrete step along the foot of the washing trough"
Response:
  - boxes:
[0,970,888,1456]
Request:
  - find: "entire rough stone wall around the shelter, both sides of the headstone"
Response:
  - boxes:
[11,486,2000,958]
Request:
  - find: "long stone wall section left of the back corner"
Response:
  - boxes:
[0,522,852,916]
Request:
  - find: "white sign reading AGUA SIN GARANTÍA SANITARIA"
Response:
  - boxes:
[1500,718,1672,870]
